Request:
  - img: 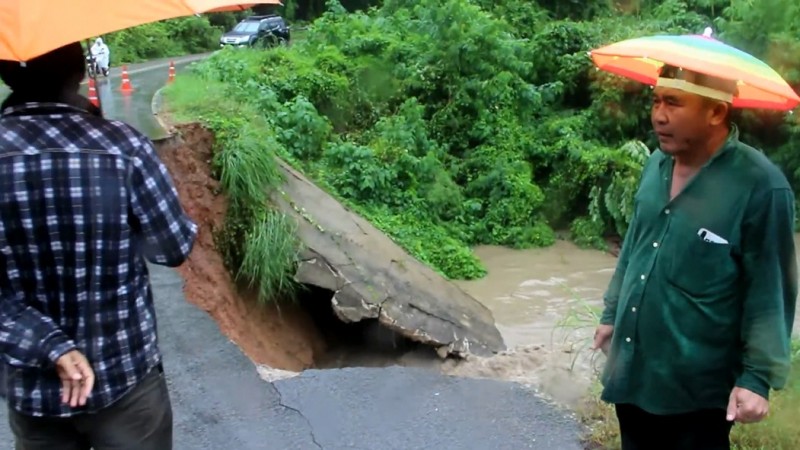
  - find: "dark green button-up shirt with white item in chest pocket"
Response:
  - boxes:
[601,127,798,414]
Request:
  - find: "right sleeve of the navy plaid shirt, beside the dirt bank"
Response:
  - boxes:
[129,135,197,267]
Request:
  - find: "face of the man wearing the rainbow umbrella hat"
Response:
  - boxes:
[650,87,719,155]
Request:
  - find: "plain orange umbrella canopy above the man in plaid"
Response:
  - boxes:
[0,0,282,61]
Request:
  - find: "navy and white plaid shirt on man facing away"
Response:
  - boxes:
[0,103,197,417]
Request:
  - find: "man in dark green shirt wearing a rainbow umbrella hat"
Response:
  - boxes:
[593,66,798,450]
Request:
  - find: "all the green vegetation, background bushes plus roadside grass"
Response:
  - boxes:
[166,0,800,450]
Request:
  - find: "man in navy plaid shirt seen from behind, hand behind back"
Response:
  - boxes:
[0,43,197,450]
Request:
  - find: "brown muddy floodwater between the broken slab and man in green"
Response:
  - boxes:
[442,241,617,406]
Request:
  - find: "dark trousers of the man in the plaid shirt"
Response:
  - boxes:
[8,366,172,450]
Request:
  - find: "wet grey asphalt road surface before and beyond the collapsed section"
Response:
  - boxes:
[0,52,582,450]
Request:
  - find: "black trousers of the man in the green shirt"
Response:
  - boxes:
[616,404,733,450]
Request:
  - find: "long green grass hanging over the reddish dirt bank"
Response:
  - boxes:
[164,73,300,304]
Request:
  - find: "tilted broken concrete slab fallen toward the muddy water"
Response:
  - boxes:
[273,159,505,357]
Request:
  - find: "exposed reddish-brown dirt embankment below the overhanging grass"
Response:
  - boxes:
[159,124,325,371]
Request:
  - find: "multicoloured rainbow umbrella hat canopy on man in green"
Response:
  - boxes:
[589,35,800,111]
